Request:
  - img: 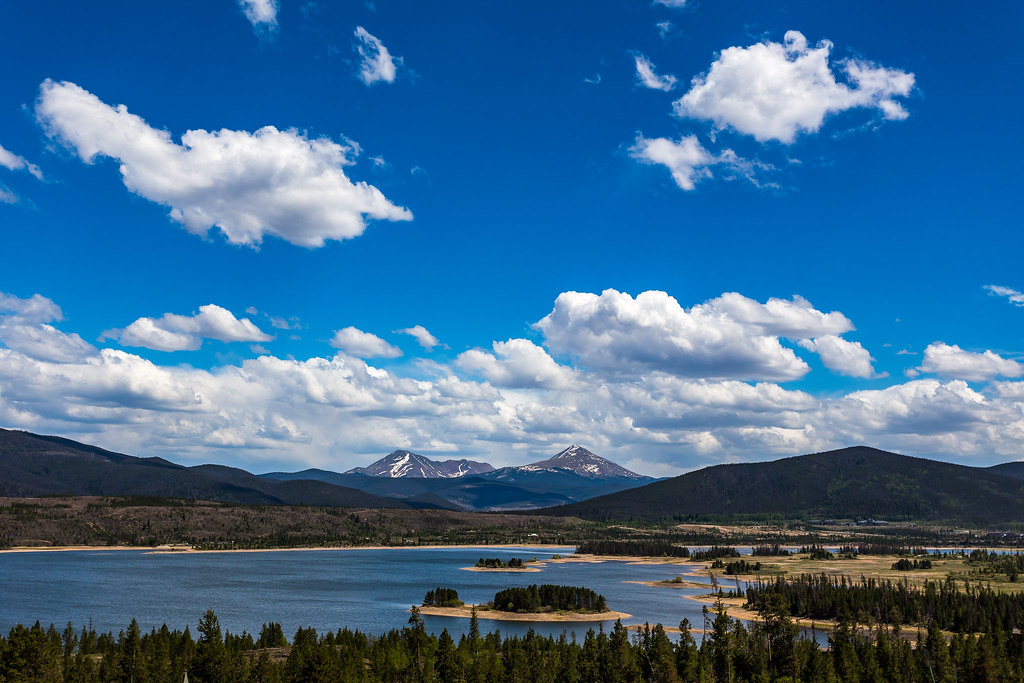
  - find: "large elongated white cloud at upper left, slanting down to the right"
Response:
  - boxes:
[36,80,413,247]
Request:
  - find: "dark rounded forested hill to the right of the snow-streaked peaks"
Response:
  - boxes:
[544,446,1024,524]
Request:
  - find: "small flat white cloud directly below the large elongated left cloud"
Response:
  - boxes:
[104,303,273,351]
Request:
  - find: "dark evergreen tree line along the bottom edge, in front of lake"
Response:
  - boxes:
[6,601,1024,683]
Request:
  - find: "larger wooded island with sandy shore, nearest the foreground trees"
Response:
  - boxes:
[411,584,630,622]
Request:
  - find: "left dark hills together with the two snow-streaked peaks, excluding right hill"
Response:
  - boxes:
[0,429,653,510]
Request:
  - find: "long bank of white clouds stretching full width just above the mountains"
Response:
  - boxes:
[6,291,1024,473]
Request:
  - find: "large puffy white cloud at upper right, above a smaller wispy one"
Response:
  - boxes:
[674,31,914,144]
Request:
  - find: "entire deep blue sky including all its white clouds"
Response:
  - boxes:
[0,0,1024,475]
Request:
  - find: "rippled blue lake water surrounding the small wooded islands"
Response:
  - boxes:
[0,548,745,639]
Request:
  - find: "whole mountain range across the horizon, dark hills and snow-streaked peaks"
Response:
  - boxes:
[6,429,1024,526]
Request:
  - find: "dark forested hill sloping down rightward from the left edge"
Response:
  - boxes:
[0,429,415,508]
